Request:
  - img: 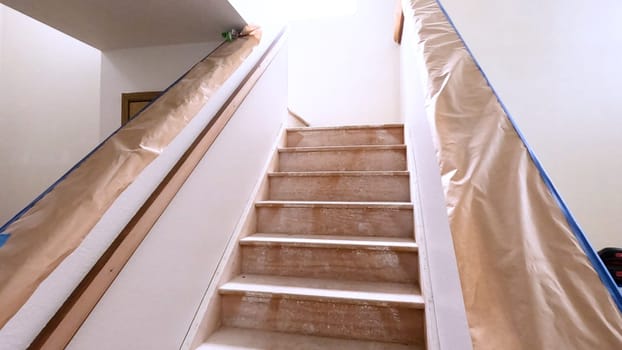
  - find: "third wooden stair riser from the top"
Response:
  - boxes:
[268,171,410,202]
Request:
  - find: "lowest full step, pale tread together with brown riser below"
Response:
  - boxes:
[220,276,423,343]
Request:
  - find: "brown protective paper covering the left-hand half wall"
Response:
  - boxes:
[0,28,261,328]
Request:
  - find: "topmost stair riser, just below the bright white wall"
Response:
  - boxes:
[286,124,404,147]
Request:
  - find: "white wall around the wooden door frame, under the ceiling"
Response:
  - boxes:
[100,42,220,139]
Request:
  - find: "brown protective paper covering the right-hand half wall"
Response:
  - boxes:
[405,0,622,350]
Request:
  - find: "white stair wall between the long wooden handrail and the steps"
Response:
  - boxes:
[68,34,287,350]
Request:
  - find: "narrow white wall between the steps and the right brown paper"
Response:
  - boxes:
[401,0,473,350]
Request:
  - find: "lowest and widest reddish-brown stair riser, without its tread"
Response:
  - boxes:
[222,295,423,345]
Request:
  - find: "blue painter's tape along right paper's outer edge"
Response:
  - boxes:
[435,0,622,312]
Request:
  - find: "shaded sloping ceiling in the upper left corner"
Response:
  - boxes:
[0,0,245,50]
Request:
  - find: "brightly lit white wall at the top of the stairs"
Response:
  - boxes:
[289,0,400,125]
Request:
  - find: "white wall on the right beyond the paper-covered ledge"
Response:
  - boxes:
[443,0,622,249]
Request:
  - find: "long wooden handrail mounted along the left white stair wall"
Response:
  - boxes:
[29,30,284,349]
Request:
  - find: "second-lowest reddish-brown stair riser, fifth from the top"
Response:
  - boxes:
[241,245,419,283]
